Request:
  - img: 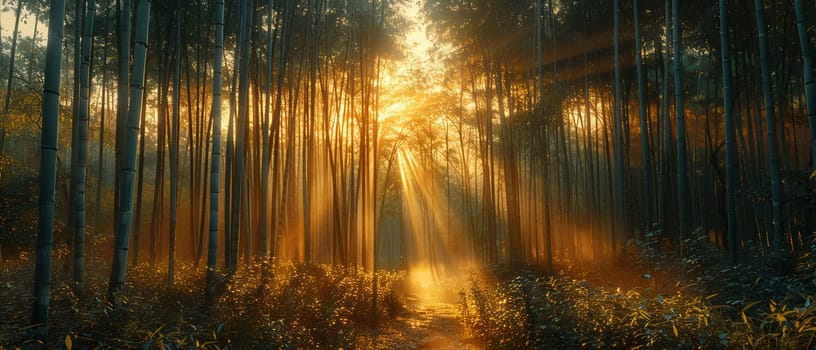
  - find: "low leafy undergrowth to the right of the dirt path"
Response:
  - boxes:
[460,273,816,349]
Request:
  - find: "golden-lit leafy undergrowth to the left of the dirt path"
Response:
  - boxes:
[0,260,403,349]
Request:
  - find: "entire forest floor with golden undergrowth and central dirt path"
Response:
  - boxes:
[0,234,816,350]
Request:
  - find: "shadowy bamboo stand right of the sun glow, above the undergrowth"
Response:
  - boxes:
[424,0,813,262]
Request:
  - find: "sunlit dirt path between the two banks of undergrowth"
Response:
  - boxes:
[361,295,481,350]
